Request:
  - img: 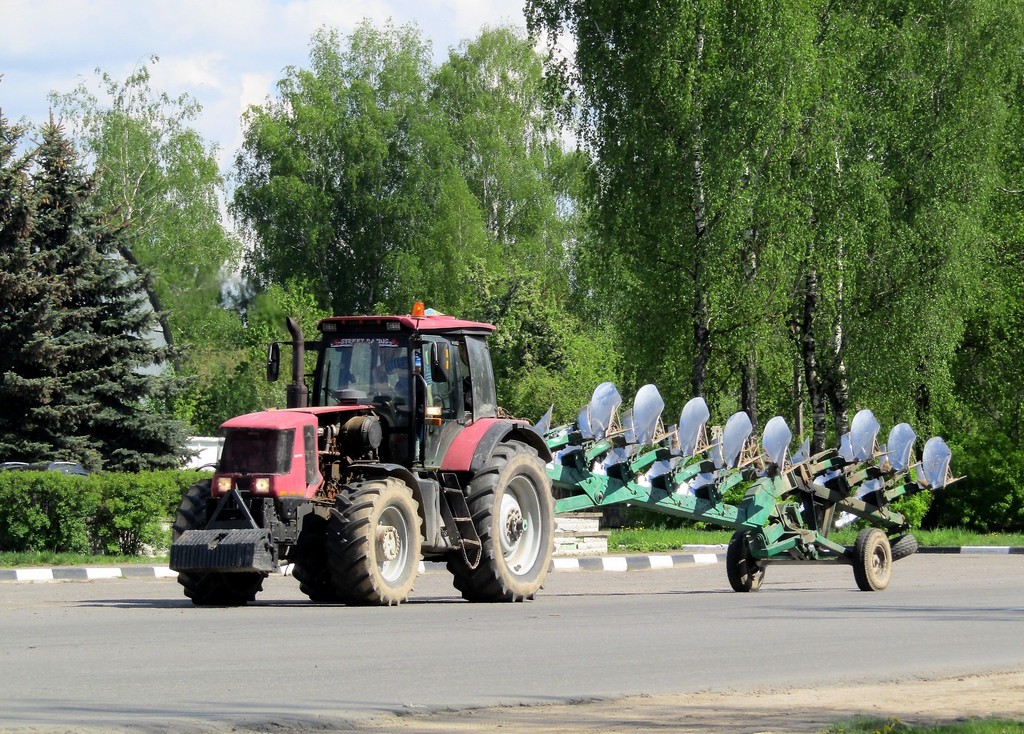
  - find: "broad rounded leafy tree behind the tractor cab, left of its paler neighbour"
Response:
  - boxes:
[232,23,461,313]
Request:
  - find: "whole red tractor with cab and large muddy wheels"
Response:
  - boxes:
[170,303,554,605]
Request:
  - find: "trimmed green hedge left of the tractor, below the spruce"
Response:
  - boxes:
[0,471,210,556]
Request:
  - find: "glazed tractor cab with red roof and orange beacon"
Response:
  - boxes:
[290,303,497,469]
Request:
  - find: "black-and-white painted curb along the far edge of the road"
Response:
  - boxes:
[0,546,1024,581]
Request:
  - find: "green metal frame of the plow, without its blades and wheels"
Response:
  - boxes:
[546,409,942,562]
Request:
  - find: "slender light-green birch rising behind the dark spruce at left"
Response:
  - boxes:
[50,56,241,352]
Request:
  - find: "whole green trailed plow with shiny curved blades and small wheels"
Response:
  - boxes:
[536,383,955,592]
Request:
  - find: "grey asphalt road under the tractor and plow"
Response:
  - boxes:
[0,555,1024,732]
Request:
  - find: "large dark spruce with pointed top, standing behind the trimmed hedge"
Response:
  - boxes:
[0,117,185,471]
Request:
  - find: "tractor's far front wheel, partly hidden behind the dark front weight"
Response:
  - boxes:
[171,480,267,606]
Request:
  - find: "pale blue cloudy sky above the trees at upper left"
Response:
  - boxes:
[0,0,525,171]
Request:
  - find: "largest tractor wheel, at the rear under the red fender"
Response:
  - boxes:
[447,441,555,602]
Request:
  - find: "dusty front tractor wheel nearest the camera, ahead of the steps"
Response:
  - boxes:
[326,477,422,606]
